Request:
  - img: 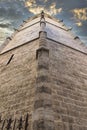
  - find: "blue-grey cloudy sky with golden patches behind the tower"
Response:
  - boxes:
[0,0,87,45]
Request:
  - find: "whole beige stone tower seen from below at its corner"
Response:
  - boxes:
[0,12,87,130]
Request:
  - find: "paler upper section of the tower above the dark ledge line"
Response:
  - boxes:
[0,11,87,54]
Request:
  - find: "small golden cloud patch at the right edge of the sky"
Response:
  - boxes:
[72,8,87,21]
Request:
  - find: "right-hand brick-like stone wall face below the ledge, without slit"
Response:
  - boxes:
[48,40,87,130]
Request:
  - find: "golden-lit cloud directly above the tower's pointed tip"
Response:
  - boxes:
[25,0,62,15]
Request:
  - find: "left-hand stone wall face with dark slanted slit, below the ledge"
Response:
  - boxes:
[0,40,38,130]
